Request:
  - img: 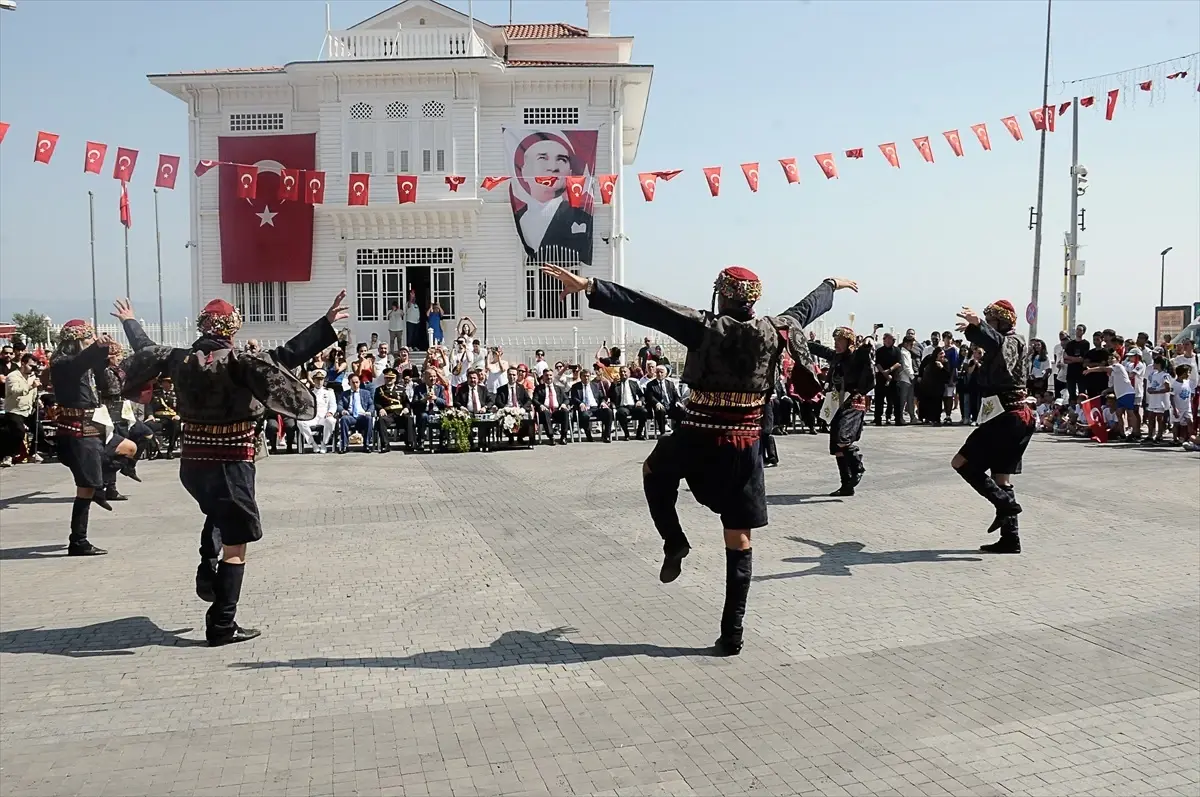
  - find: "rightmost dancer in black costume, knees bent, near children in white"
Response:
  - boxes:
[950,299,1033,553]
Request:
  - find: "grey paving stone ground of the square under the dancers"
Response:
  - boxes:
[0,427,1200,797]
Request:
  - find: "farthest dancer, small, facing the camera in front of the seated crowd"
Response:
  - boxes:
[809,326,875,496]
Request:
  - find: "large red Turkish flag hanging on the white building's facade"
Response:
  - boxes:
[217,133,317,284]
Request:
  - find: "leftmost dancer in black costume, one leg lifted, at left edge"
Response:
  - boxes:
[50,318,138,556]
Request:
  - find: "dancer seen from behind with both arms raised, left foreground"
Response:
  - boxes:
[114,290,349,647]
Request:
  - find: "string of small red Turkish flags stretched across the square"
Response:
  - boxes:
[0,70,1200,208]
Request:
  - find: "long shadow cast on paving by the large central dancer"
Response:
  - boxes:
[229,628,713,670]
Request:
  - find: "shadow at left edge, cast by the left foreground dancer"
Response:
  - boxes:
[0,617,206,658]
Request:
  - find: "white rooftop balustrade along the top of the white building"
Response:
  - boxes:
[323,28,496,61]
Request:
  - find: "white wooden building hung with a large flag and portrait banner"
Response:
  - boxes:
[149,0,653,350]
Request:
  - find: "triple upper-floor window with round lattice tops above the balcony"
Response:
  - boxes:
[346,100,451,174]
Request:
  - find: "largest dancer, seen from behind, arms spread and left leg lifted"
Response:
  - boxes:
[542,264,858,655]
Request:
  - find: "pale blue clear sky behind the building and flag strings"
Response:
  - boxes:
[0,0,1200,336]
